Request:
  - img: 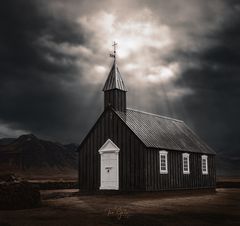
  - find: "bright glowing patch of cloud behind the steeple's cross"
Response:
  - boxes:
[78,9,179,86]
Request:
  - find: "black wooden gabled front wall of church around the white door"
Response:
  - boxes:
[79,109,146,191]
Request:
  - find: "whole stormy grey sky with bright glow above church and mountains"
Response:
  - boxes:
[0,0,240,159]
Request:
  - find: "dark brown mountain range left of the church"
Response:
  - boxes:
[0,134,77,177]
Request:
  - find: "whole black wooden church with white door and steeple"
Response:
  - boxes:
[78,46,216,192]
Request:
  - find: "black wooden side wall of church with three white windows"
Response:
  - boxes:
[146,149,216,191]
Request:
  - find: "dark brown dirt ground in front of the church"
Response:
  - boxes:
[0,189,240,226]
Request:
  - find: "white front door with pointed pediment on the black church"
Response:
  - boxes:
[99,139,119,190]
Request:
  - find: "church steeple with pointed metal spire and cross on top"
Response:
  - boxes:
[103,42,127,111]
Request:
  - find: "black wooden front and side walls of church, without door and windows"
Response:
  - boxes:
[79,107,216,191]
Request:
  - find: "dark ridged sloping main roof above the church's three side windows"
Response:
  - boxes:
[115,109,216,154]
